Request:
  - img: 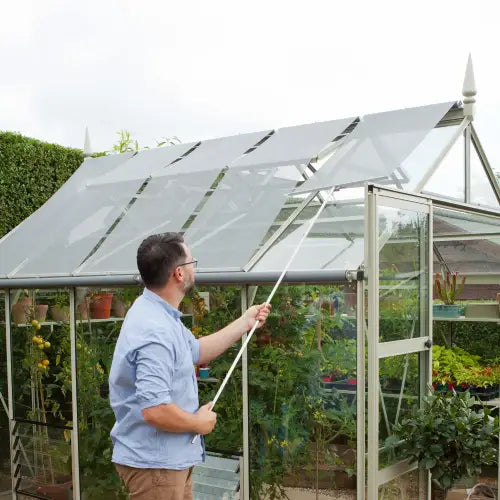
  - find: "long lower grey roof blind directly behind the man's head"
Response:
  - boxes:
[79,170,220,274]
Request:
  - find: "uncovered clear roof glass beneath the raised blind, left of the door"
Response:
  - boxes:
[253,204,364,271]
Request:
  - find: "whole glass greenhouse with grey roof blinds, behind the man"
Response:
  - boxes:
[0,67,500,500]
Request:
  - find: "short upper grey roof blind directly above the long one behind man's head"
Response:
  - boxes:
[153,131,269,177]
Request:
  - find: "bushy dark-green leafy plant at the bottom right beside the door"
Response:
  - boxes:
[386,392,500,498]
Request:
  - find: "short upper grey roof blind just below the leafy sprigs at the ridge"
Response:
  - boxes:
[90,142,196,185]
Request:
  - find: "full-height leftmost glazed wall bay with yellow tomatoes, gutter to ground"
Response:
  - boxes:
[10,290,73,498]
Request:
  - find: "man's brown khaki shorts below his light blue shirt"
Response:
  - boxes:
[115,464,193,500]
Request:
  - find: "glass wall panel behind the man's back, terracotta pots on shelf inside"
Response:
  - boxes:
[75,287,141,500]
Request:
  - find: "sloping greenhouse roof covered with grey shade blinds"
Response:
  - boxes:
[0,102,499,278]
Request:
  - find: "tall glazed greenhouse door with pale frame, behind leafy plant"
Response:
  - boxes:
[365,185,432,500]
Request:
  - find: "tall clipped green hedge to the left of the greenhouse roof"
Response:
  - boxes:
[0,131,83,237]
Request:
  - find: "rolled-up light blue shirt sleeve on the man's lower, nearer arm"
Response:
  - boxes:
[135,342,175,410]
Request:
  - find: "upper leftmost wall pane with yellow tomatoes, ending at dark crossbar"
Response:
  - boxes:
[11,290,73,428]
